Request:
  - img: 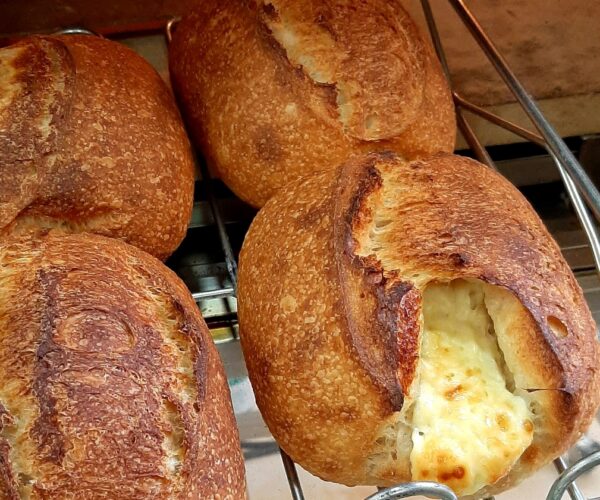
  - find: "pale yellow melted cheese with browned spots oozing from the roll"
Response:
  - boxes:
[410,281,533,495]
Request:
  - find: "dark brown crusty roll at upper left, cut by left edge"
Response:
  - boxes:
[0,35,194,258]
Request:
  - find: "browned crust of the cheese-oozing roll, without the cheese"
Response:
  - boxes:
[239,153,600,497]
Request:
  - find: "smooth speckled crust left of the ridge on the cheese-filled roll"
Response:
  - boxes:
[238,168,390,484]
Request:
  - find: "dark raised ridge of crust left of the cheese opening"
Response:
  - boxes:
[334,157,421,411]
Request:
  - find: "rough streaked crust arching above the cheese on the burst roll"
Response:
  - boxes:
[350,155,597,400]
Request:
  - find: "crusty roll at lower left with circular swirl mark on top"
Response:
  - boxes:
[0,231,245,500]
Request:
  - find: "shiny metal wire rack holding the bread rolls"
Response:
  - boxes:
[52,0,600,500]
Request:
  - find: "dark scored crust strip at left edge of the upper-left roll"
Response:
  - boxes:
[0,38,74,229]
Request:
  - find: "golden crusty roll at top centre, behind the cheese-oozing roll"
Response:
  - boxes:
[169,0,456,206]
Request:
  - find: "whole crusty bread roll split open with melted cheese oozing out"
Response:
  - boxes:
[239,153,600,498]
